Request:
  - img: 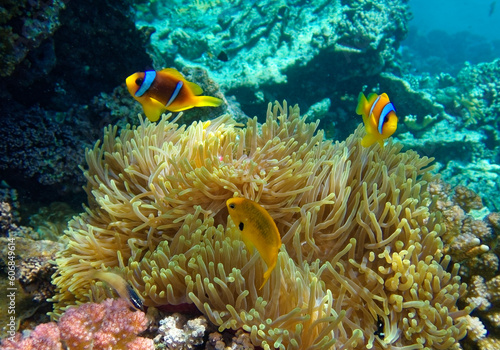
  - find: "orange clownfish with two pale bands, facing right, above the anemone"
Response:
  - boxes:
[356,92,398,147]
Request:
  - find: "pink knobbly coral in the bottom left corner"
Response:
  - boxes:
[1,299,154,350]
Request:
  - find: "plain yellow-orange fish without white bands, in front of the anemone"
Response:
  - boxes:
[226,197,281,289]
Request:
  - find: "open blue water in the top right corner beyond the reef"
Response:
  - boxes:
[401,0,500,74]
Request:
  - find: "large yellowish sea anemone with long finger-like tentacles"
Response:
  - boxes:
[54,104,470,350]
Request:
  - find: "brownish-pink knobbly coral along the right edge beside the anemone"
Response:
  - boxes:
[429,181,500,350]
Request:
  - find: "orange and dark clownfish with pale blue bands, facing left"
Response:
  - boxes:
[126,68,222,122]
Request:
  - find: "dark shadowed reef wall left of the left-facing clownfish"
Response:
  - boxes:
[0,0,151,216]
